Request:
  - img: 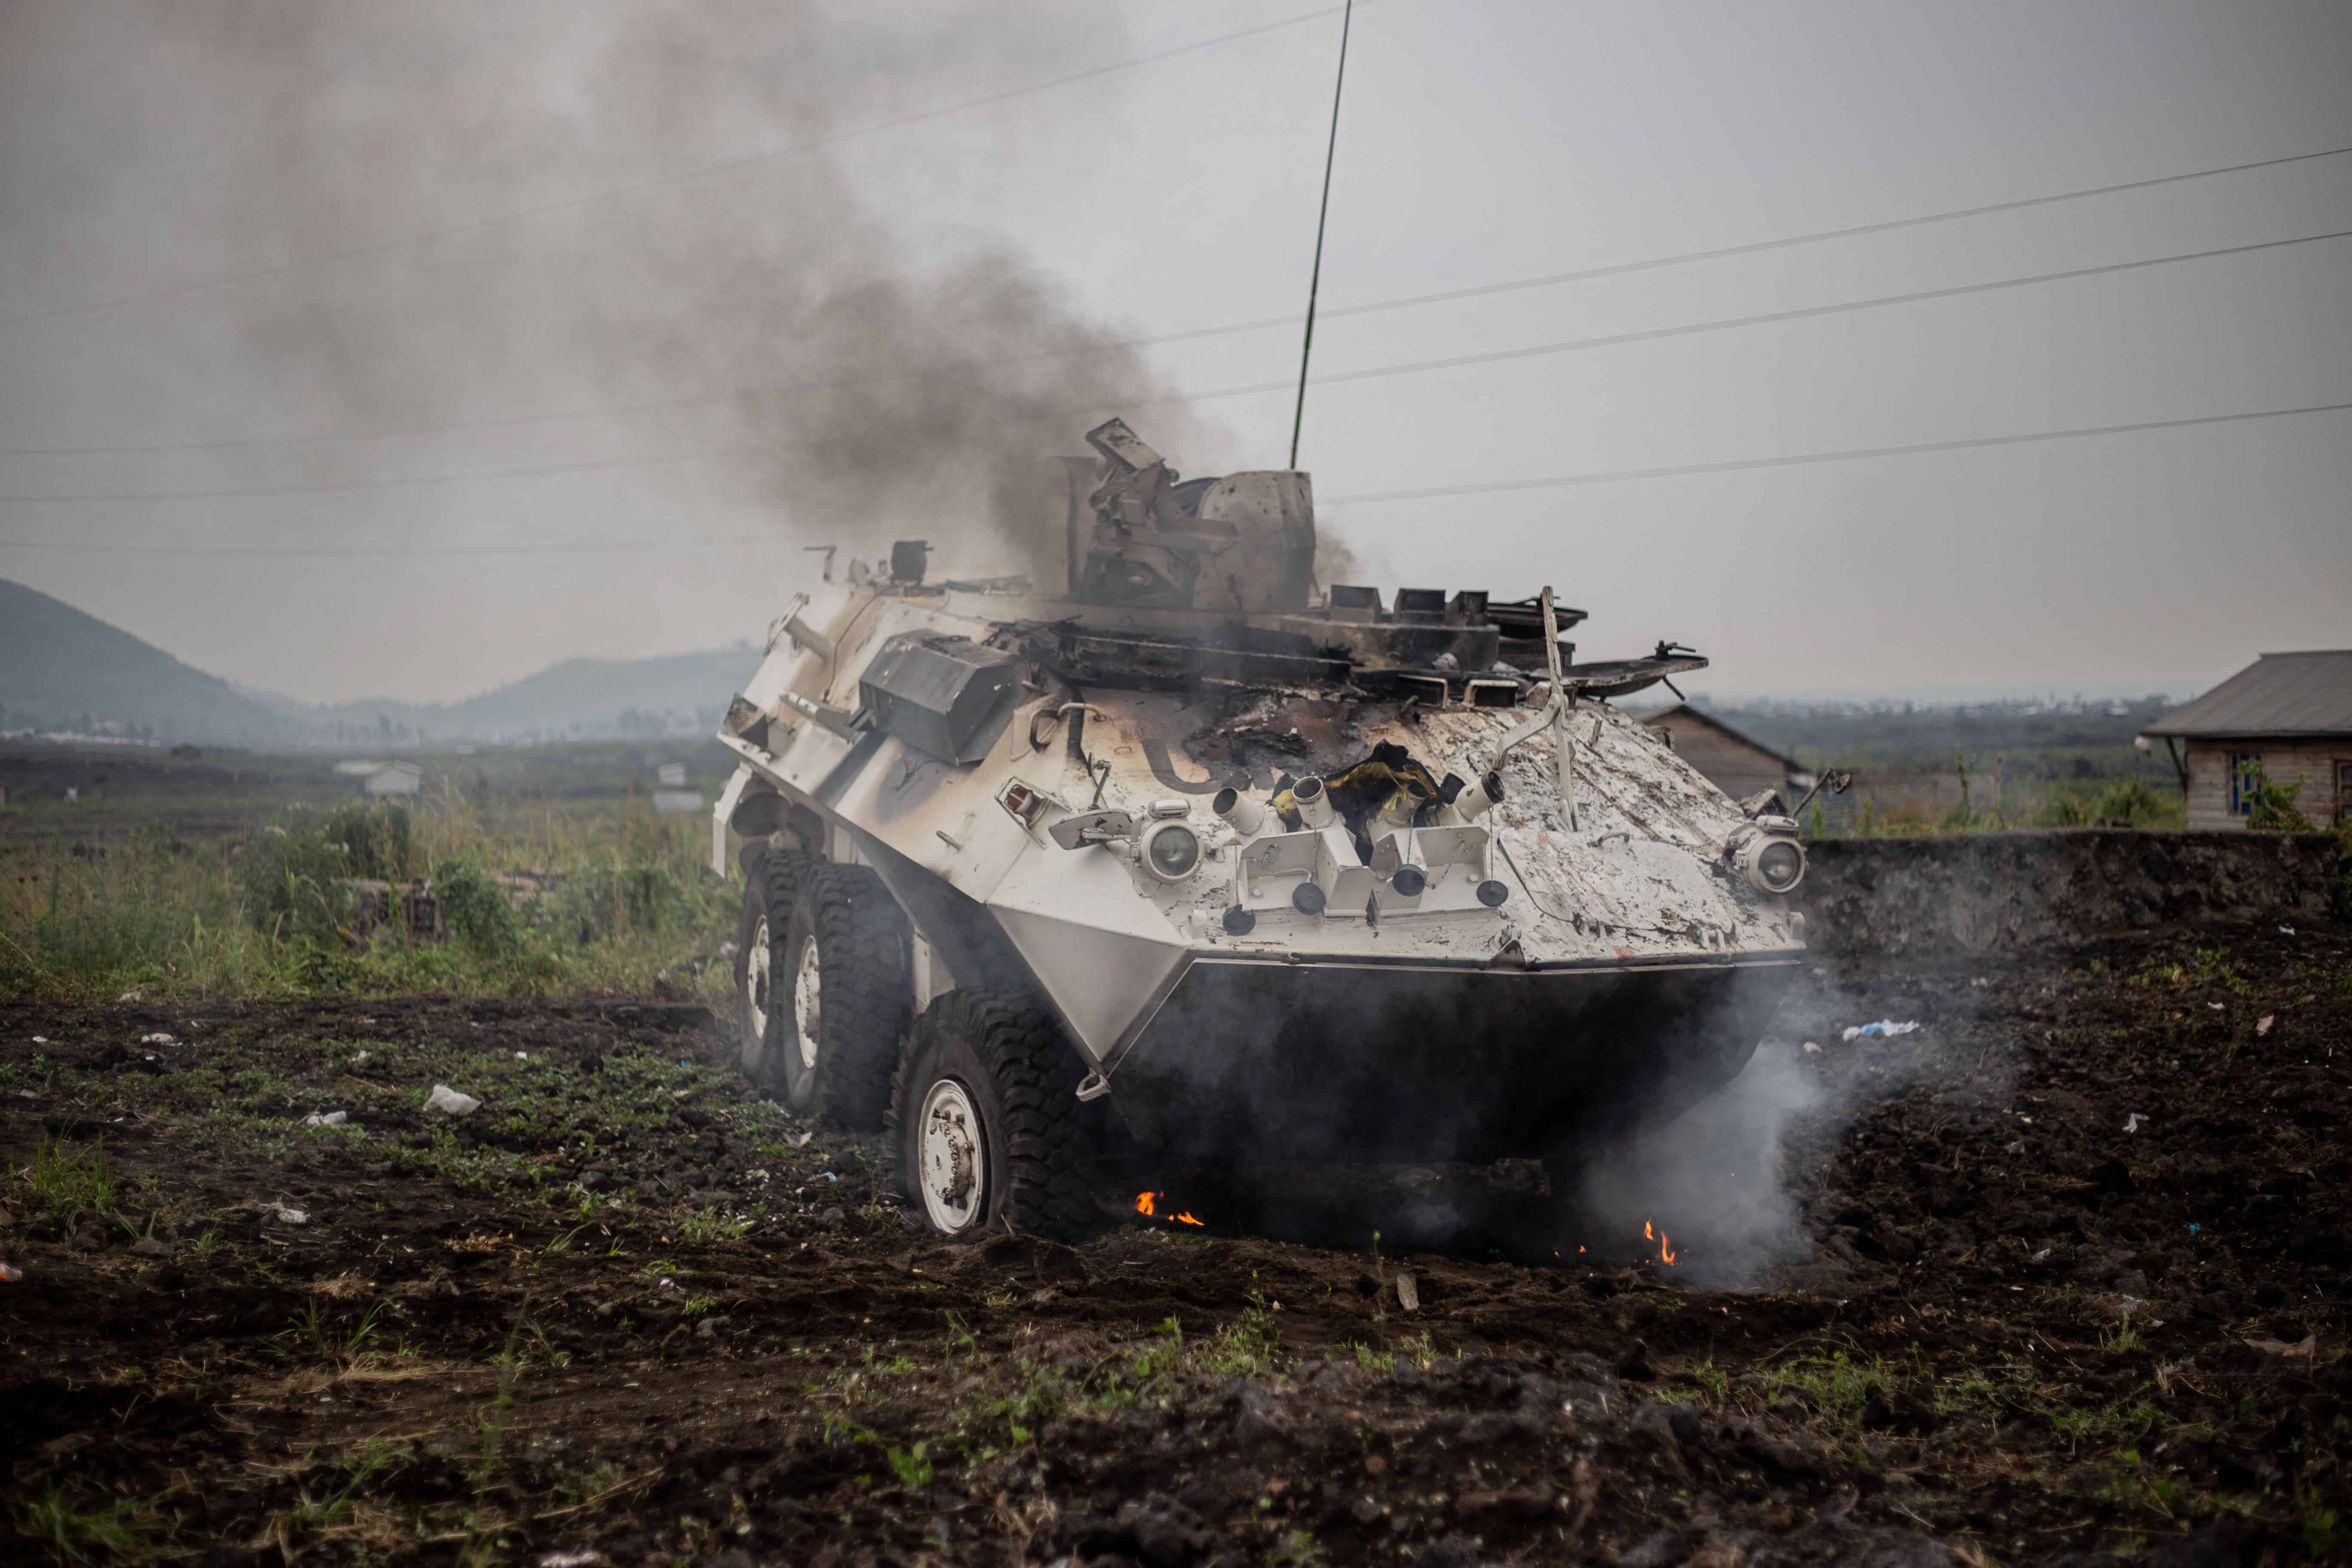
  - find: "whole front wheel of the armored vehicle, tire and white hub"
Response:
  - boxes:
[891,990,1098,1241]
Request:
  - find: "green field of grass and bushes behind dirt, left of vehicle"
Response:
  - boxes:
[0,747,738,999]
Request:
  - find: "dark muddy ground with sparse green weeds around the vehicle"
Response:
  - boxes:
[0,924,2352,1568]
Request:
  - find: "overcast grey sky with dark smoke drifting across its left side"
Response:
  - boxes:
[0,0,2352,701]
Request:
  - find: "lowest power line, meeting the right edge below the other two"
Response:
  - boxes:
[0,399,2352,557]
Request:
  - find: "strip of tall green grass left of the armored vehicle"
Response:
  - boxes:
[0,797,738,999]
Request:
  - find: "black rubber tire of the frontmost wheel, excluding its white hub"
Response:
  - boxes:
[889,990,1103,1241]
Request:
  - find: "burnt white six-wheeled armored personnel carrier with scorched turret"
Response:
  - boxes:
[713,421,1804,1234]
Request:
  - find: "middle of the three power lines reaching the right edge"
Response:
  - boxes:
[0,228,2352,503]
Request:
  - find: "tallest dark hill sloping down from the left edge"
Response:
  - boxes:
[0,581,301,745]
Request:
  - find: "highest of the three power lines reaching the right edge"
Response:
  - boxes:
[0,138,2352,456]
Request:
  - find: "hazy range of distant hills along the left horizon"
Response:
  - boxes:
[0,581,760,747]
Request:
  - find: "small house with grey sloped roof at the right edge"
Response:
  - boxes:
[2141,649,2352,827]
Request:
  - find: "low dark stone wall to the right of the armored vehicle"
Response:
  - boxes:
[1797,827,2340,957]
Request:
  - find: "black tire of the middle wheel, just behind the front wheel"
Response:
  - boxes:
[767,863,915,1133]
